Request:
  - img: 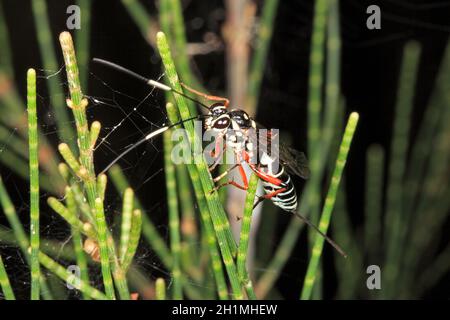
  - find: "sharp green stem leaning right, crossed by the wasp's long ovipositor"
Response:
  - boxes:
[301,112,359,300]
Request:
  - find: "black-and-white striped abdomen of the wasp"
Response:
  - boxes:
[262,167,297,212]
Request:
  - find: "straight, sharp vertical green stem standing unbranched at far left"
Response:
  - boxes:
[27,69,40,300]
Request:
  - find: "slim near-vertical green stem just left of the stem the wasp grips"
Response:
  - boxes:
[163,129,183,300]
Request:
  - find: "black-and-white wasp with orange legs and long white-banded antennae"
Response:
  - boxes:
[93,58,347,257]
